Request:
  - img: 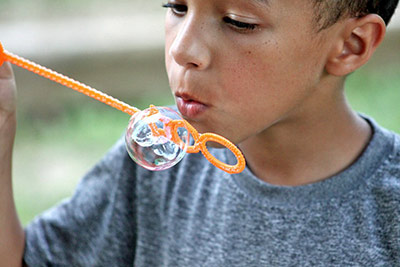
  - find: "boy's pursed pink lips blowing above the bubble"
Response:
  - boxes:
[175,93,208,119]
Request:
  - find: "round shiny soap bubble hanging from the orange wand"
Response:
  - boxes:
[125,107,189,171]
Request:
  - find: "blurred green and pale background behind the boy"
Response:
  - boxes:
[0,0,400,224]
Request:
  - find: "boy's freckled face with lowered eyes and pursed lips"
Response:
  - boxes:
[165,0,338,143]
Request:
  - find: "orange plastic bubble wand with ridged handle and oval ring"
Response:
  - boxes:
[0,42,246,174]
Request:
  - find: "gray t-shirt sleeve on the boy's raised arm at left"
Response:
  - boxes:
[24,140,136,266]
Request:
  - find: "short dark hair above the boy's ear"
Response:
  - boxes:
[312,0,399,30]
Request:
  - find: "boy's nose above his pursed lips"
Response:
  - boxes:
[169,16,211,70]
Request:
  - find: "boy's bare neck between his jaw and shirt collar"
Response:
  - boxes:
[240,90,371,186]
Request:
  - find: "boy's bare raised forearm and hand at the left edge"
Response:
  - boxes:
[0,63,24,266]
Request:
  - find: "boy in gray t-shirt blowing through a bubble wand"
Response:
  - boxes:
[0,0,400,266]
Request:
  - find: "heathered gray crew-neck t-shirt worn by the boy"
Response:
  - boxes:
[25,118,400,267]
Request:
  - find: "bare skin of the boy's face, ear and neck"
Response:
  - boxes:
[165,0,384,185]
